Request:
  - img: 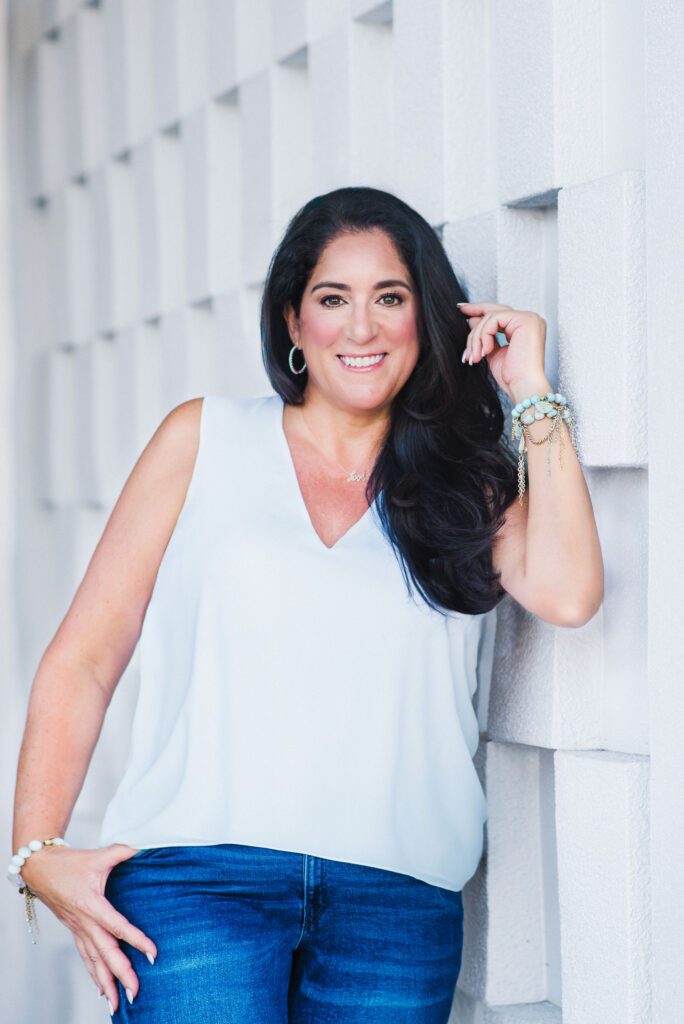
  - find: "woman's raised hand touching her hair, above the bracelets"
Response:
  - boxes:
[459,302,546,401]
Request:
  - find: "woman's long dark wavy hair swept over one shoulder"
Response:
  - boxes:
[261,187,517,614]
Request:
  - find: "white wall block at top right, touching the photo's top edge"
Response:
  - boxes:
[491,0,644,203]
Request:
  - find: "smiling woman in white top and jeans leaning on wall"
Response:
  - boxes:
[9,188,603,1024]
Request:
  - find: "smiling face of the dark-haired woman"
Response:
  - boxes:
[285,228,419,413]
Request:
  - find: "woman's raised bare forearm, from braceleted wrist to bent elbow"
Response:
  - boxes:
[512,377,603,625]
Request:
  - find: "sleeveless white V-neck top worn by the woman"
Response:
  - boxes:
[100,395,496,891]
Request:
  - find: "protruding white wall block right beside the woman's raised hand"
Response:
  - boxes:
[558,171,648,466]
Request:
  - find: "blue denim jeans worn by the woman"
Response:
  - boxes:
[105,843,463,1024]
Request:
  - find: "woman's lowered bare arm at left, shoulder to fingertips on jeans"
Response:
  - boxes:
[13,398,202,1008]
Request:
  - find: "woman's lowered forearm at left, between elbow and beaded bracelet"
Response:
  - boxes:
[12,648,109,850]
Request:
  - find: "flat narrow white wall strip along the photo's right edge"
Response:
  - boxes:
[643,0,684,1024]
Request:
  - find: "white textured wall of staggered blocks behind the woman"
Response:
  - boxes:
[0,0,663,1024]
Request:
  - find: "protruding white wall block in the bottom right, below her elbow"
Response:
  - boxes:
[555,751,651,1024]
